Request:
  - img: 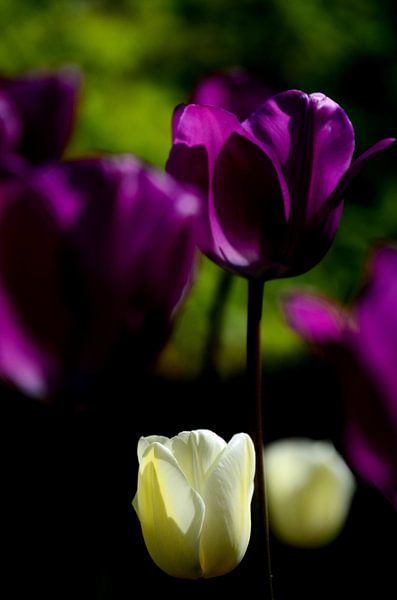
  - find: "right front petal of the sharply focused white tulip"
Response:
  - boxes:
[200,433,255,577]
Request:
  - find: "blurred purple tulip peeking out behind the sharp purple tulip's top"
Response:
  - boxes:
[191,69,273,121]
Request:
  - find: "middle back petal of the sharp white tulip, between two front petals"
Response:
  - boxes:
[169,429,226,494]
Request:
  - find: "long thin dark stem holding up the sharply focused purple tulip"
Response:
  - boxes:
[247,279,274,600]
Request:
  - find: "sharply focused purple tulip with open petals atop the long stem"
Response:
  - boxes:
[167,90,394,280]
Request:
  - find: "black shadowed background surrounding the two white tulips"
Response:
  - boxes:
[1,359,397,600]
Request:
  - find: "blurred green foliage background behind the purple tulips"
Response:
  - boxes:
[0,0,397,378]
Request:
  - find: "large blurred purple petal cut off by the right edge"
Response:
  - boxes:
[338,247,397,508]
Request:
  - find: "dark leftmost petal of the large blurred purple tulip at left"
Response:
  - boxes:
[0,176,72,391]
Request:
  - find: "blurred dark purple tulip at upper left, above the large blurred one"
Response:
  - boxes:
[0,68,80,170]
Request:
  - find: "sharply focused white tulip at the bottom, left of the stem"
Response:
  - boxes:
[133,429,255,579]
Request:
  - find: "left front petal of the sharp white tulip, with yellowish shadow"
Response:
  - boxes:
[133,442,205,579]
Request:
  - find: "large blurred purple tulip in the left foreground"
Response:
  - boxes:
[0,156,199,397]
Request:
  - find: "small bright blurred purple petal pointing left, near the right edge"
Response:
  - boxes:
[283,292,346,345]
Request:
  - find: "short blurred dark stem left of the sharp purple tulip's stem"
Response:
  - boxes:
[202,269,234,376]
